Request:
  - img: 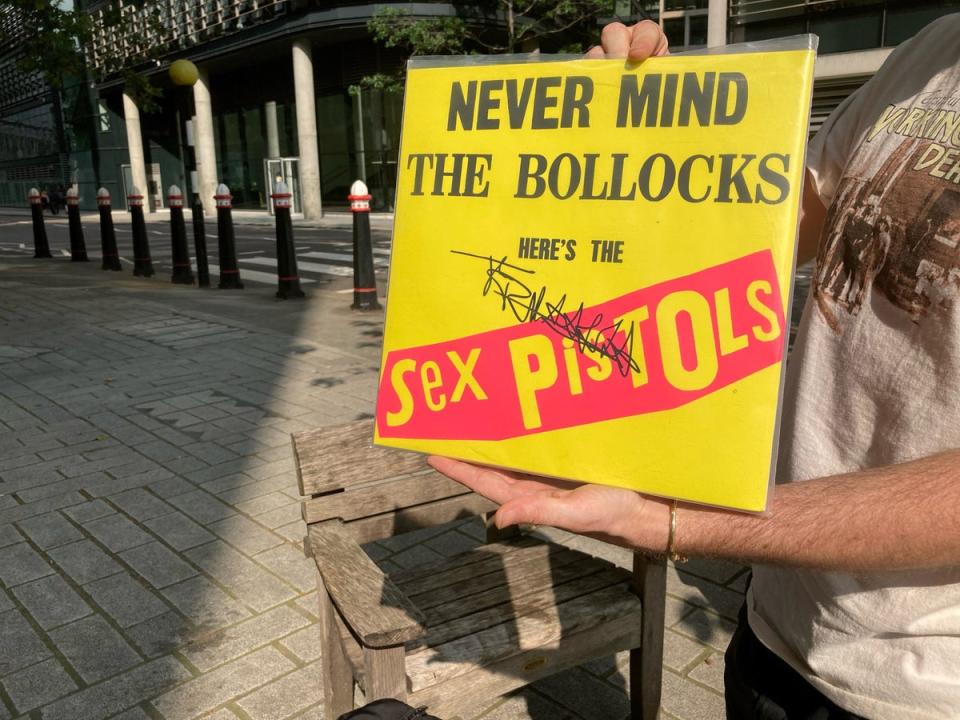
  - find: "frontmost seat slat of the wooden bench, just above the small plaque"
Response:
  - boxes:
[407,583,641,692]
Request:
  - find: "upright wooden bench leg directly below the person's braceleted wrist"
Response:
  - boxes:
[630,553,667,720]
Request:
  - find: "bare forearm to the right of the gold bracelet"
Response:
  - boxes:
[675,451,960,571]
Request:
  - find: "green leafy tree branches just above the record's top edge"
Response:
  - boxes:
[361,0,614,90]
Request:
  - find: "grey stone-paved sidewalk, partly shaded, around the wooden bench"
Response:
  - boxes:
[0,255,744,720]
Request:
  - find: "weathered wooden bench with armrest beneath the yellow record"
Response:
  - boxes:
[293,421,665,720]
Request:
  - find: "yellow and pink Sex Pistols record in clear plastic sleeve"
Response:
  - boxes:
[375,36,816,512]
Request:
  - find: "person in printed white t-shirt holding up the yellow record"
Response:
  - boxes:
[430,14,960,720]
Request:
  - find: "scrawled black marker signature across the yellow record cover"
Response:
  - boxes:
[450,250,640,376]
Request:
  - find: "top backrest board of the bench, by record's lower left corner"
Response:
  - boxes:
[293,420,427,496]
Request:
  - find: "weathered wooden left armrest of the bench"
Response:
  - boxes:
[307,521,426,648]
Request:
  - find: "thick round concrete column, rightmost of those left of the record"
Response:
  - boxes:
[293,39,323,220]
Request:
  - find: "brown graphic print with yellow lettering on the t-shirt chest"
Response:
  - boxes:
[813,96,960,332]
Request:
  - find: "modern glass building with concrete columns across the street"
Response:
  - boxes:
[0,0,960,218]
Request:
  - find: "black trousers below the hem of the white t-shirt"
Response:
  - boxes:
[723,606,864,720]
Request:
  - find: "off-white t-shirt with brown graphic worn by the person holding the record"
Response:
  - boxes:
[747,14,960,720]
